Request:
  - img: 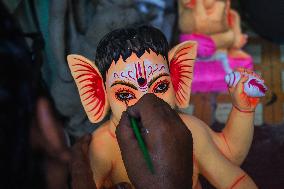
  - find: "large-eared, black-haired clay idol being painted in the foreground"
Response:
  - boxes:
[67,26,258,188]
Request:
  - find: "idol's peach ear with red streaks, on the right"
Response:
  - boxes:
[169,41,197,108]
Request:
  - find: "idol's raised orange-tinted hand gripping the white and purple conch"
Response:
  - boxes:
[229,68,262,112]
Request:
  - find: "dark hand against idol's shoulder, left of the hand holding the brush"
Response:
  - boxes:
[69,134,131,189]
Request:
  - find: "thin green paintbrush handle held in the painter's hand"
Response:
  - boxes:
[130,117,154,173]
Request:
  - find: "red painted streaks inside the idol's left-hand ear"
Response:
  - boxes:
[72,58,105,117]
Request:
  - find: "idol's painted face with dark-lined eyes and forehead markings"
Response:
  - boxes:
[105,51,175,121]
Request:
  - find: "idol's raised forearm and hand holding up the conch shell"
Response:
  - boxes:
[219,68,260,165]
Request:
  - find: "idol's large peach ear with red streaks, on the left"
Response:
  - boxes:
[67,55,109,123]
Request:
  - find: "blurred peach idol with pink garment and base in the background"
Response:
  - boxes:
[178,0,253,92]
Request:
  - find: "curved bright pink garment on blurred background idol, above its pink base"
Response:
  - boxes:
[179,33,216,58]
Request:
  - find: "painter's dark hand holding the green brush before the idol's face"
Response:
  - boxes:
[116,94,193,189]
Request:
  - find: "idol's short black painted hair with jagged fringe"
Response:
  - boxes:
[95,25,169,81]
